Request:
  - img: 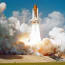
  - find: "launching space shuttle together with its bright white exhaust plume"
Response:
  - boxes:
[30,4,41,47]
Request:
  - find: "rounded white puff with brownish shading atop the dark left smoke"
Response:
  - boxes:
[8,17,20,35]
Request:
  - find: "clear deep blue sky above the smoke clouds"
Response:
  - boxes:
[0,0,65,17]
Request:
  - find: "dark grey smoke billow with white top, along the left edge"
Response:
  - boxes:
[0,16,20,50]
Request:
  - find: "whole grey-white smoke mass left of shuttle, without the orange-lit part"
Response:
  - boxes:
[0,10,30,50]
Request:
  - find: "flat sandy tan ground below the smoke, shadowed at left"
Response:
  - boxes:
[0,55,65,63]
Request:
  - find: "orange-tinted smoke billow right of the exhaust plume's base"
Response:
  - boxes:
[38,38,55,56]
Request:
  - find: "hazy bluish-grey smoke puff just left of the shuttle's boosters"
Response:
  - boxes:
[13,9,31,24]
